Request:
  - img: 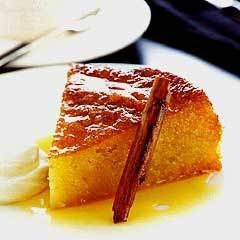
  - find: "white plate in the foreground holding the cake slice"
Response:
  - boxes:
[0,63,240,240]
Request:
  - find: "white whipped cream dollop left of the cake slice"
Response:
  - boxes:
[0,144,48,204]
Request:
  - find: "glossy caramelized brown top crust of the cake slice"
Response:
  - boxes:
[50,65,208,155]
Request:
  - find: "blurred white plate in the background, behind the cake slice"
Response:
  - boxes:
[5,0,151,67]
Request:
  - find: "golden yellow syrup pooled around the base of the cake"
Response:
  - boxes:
[15,137,221,227]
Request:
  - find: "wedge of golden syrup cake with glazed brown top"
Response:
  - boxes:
[49,65,222,208]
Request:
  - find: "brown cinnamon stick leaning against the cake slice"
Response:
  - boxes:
[113,76,170,223]
